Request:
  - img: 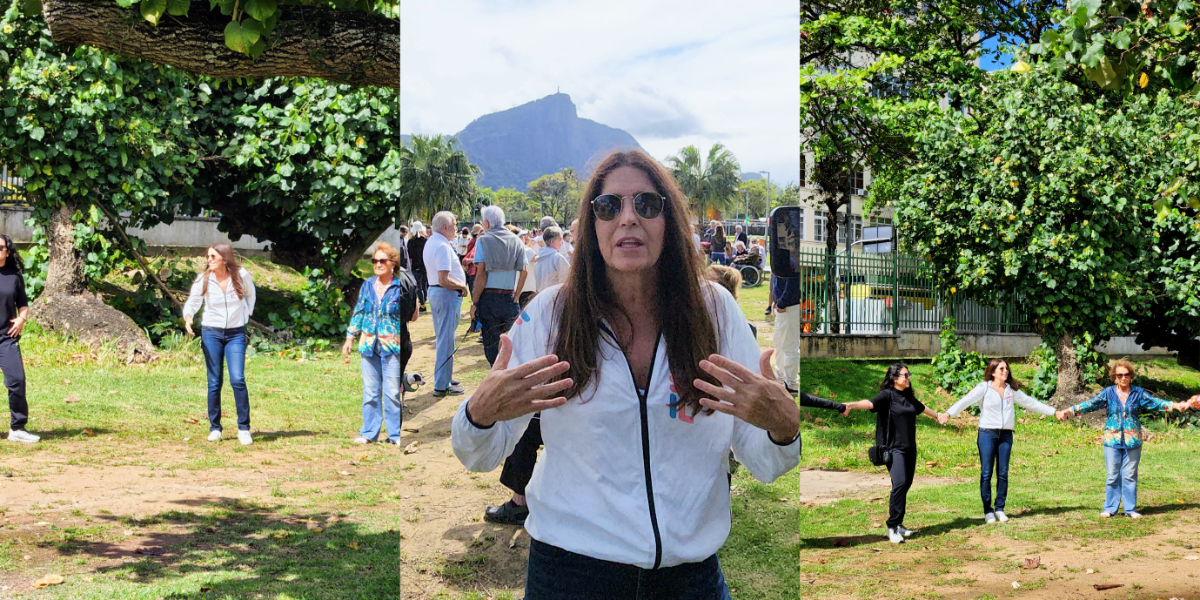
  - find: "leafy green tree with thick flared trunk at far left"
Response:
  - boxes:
[0,2,199,359]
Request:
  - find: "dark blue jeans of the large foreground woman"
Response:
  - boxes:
[526,540,730,600]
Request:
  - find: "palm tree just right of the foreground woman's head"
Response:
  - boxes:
[667,144,742,223]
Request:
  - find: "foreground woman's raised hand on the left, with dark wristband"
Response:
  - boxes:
[467,334,571,427]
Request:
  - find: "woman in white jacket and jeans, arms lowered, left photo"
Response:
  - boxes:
[184,244,254,445]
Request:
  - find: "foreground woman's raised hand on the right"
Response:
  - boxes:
[692,349,801,440]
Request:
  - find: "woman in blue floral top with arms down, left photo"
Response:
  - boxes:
[342,241,418,445]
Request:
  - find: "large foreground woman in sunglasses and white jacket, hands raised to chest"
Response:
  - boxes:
[451,150,800,600]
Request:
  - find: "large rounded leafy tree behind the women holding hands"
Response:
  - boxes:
[895,71,1181,397]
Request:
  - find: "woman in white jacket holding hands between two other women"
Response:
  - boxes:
[938,359,1055,523]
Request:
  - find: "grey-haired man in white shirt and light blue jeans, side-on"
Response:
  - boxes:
[422,211,469,398]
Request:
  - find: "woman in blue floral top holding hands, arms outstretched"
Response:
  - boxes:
[1055,360,1177,518]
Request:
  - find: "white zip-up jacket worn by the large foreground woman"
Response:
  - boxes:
[451,282,800,569]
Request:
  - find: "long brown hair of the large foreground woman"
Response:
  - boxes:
[554,150,720,414]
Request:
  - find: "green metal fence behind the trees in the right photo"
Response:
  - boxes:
[796,248,1030,334]
